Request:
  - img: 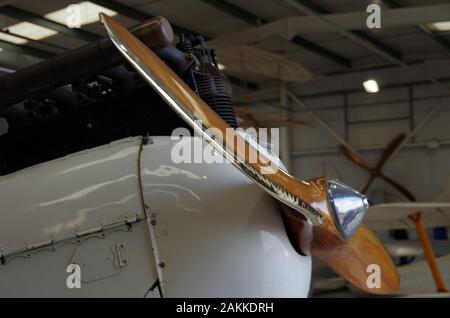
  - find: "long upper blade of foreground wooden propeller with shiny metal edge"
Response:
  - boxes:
[100,13,322,226]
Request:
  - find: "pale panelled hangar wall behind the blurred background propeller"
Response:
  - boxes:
[291,81,450,201]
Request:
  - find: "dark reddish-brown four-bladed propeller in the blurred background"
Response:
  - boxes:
[340,134,416,201]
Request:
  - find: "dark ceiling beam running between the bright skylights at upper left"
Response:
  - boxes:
[0,5,100,42]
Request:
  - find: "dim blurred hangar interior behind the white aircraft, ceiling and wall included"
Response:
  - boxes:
[0,0,450,297]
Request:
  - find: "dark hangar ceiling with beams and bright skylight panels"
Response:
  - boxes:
[0,0,450,94]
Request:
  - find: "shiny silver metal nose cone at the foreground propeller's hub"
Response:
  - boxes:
[327,180,369,240]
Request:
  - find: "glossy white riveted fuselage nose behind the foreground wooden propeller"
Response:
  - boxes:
[0,137,311,297]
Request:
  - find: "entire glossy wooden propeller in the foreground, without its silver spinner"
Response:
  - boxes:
[101,14,398,294]
